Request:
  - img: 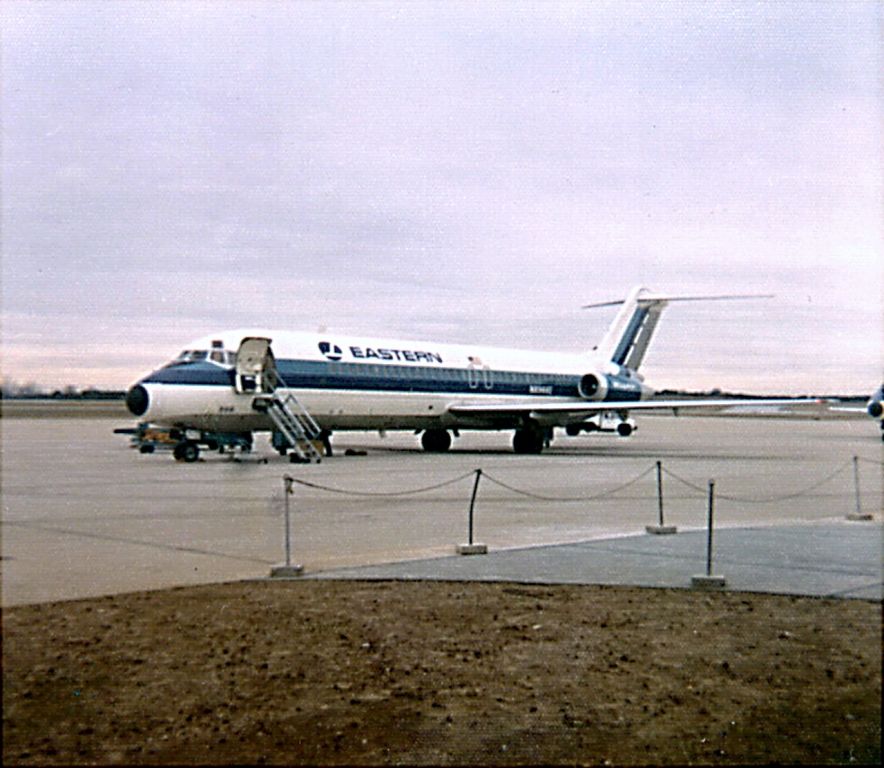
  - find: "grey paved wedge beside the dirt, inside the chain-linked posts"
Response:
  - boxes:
[304,520,882,601]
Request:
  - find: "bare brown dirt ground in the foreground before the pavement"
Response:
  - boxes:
[3,581,881,765]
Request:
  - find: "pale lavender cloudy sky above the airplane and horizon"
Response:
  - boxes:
[0,0,884,394]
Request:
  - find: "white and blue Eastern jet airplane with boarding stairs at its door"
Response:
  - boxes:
[126,287,820,462]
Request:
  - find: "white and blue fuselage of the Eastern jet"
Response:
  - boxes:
[130,330,652,432]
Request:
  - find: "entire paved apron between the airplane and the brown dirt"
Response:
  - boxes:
[0,404,884,607]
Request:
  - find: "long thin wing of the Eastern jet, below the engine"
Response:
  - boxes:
[448,398,824,417]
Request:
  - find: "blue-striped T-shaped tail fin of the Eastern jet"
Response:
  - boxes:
[583,286,772,370]
